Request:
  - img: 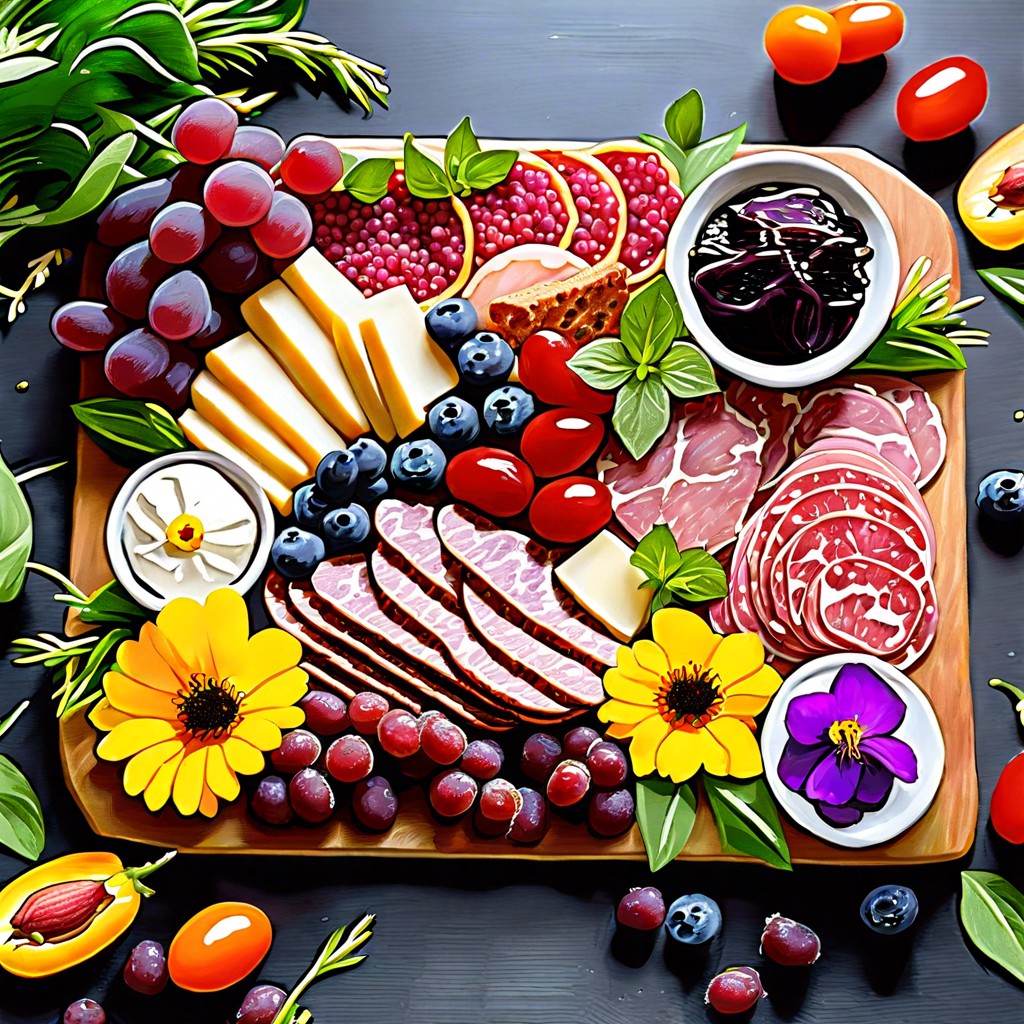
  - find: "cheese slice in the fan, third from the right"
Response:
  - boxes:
[242,281,370,440]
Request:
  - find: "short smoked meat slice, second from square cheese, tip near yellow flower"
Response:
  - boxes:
[462,584,604,707]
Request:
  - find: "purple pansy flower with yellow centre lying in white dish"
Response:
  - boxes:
[778,664,918,828]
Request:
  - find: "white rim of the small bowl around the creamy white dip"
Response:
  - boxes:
[105,452,273,611]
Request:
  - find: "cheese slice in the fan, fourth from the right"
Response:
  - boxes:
[206,332,345,466]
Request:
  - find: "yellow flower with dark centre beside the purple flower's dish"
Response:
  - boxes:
[598,608,782,782]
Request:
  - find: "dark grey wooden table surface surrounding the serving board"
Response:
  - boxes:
[0,0,1024,1024]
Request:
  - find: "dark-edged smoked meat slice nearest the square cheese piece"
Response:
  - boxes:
[437,505,618,667]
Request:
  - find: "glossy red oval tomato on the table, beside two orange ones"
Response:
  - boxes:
[896,57,988,142]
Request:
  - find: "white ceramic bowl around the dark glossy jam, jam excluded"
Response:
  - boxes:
[666,150,899,387]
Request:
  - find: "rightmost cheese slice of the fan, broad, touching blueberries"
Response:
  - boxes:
[359,285,459,437]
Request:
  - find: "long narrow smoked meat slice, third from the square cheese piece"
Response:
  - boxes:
[370,548,569,722]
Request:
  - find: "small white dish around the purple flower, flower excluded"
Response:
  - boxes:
[761,654,946,849]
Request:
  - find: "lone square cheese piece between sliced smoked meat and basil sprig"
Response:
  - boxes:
[555,529,653,643]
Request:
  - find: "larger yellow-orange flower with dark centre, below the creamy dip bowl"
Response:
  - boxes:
[89,588,307,818]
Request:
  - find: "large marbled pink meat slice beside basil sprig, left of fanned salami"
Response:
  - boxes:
[598,394,765,553]
